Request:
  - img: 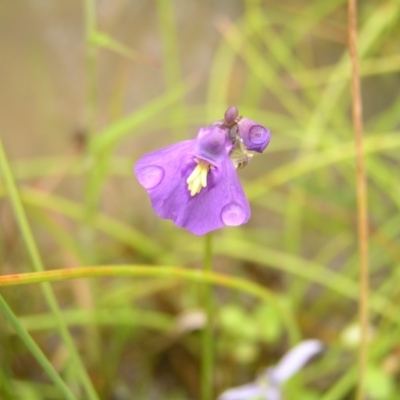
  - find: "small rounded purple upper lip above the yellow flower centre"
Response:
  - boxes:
[194,125,232,166]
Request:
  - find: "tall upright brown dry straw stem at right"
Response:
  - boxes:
[349,0,369,400]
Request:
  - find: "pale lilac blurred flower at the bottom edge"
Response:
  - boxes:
[218,339,323,400]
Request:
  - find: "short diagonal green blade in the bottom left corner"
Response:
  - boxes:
[0,295,75,400]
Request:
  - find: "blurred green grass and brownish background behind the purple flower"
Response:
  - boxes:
[0,0,400,400]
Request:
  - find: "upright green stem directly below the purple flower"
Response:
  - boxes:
[201,233,214,400]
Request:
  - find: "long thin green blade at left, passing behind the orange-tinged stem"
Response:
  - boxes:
[0,140,98,400]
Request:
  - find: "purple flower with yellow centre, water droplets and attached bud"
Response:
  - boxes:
[134,107,269,235]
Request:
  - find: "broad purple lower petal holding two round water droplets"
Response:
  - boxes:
[134,141,250,235]
